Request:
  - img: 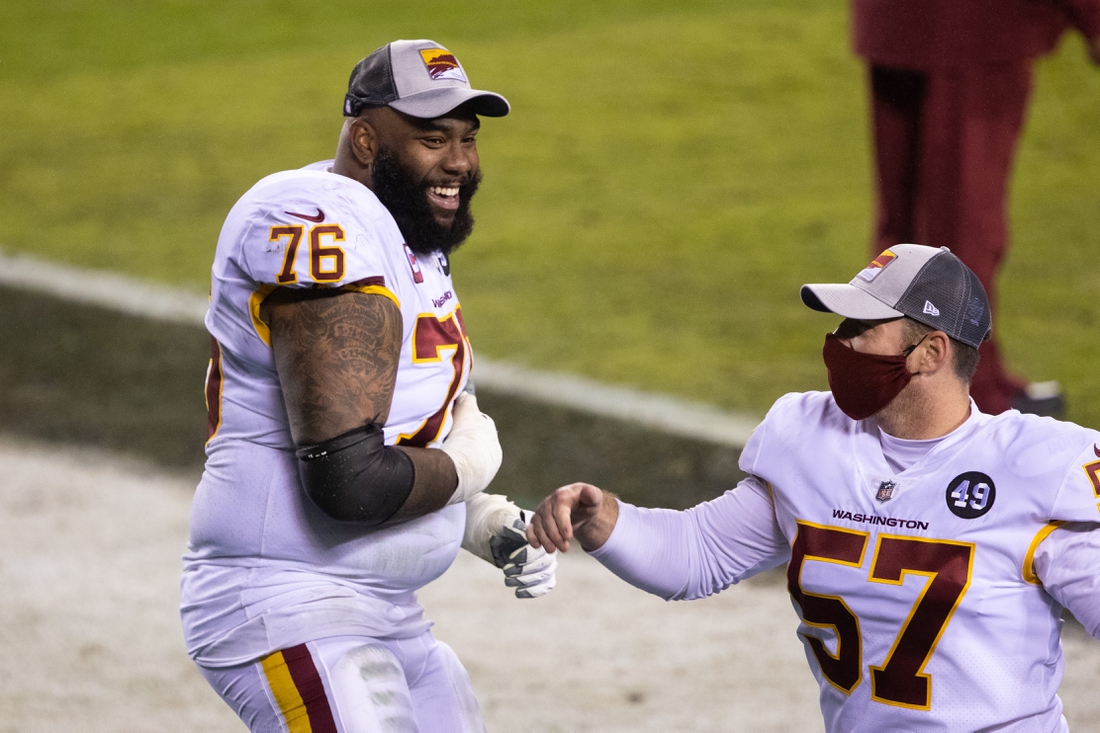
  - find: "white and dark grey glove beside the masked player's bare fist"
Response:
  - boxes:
[462,493,558,598]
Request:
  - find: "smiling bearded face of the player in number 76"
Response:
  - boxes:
[367,106,481,254]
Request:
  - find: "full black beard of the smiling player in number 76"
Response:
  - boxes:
[371,147,481,255]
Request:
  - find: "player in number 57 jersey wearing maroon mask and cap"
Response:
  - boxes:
[528,244,1100,733]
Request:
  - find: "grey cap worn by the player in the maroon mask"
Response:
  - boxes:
[800,244,992,349]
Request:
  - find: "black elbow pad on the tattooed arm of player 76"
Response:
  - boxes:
[296,423,415,526]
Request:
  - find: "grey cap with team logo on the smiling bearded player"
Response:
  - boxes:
[343,40,510,119]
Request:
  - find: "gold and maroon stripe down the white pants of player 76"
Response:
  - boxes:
[261,644,338,733]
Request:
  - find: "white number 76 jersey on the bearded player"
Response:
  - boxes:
[182,161,473,667]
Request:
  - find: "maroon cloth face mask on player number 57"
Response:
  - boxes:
[822,333,923,420]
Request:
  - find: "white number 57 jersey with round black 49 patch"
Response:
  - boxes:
[739,393,1100,733]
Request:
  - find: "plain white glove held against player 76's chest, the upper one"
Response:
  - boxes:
[440,392,503,504]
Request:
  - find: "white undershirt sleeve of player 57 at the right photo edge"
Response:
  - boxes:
[1032,522,1100,638]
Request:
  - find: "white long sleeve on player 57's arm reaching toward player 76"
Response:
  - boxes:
[592,477,791,601]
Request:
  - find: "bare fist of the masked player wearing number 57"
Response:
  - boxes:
[527,483,618,553]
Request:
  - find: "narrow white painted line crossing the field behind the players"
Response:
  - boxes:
[0,251,758,448]
